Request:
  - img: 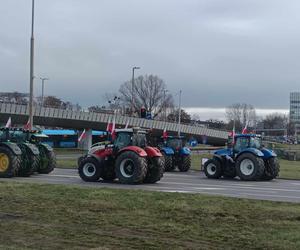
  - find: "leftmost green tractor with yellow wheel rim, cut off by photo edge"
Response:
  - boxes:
[0,129,22,178]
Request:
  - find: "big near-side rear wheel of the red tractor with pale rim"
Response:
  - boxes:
[115,151,147,184]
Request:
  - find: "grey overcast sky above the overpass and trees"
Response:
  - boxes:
[0,0,300,109]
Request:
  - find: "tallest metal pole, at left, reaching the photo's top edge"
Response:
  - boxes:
[29,0,34,129]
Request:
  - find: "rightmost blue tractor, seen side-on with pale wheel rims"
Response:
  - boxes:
[204,134,280,181]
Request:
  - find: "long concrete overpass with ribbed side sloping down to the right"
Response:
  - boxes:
[0,103,228,145]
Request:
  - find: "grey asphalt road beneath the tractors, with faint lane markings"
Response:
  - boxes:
[2,169,300,203]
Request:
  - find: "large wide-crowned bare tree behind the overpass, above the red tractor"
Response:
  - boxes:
[119,75,174,118]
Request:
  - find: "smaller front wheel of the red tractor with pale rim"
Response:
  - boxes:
[78,157,103,182]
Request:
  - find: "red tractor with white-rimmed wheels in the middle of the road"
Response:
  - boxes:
[78,129,164,184]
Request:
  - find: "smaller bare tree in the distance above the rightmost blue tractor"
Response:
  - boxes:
[225,103,256,131]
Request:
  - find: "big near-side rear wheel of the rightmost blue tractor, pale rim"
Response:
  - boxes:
[235,153,265,181]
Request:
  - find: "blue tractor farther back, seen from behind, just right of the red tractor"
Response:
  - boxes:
[160,136,191,172]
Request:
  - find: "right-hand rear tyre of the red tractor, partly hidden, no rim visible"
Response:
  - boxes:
[144,157,165,183]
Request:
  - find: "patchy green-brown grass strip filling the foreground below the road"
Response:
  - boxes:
[0,182,300,249]
